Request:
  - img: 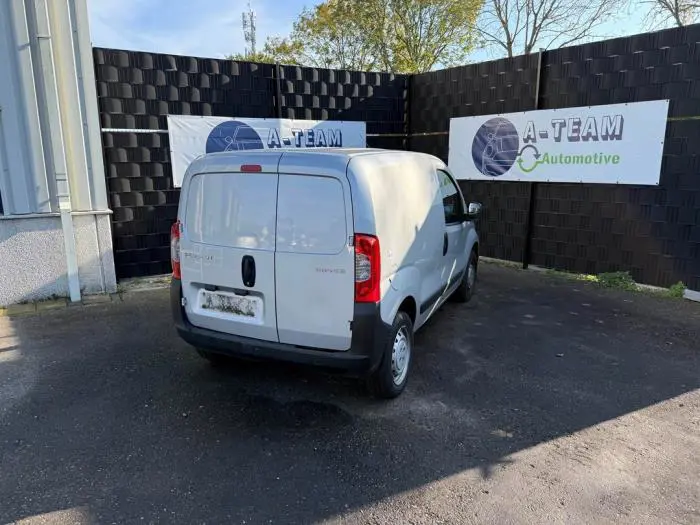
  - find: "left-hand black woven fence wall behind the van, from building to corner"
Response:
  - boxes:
[94,48,408,278]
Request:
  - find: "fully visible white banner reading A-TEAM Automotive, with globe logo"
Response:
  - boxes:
[448,100,668,185]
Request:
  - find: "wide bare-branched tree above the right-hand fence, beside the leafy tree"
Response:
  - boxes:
[478,0,625,57]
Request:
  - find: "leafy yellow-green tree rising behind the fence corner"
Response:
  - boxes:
[230,0,483,73]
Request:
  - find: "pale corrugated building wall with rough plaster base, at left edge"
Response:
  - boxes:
[0,0,116,306]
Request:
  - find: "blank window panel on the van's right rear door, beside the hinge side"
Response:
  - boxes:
[277,175,348,254]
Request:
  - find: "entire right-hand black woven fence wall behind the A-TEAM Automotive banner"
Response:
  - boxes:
[410,25,700,290]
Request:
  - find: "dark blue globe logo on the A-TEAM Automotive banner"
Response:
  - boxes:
[472,117,520,177]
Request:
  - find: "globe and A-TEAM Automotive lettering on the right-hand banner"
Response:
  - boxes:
[472,115,625,177]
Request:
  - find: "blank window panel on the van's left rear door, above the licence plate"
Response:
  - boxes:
[185,173,277,251]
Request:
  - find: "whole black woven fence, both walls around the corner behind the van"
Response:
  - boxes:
[94,25,700,289]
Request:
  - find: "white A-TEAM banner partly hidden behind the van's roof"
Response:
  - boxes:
[168,115,367,188]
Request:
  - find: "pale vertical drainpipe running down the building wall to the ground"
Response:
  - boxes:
[26,0,80,302]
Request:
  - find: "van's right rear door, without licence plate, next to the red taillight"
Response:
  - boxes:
[275,162,355,350]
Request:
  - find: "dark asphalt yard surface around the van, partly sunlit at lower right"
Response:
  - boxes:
[0,265,700,524]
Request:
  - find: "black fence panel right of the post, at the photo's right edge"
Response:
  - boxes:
[531,25,700,290]
